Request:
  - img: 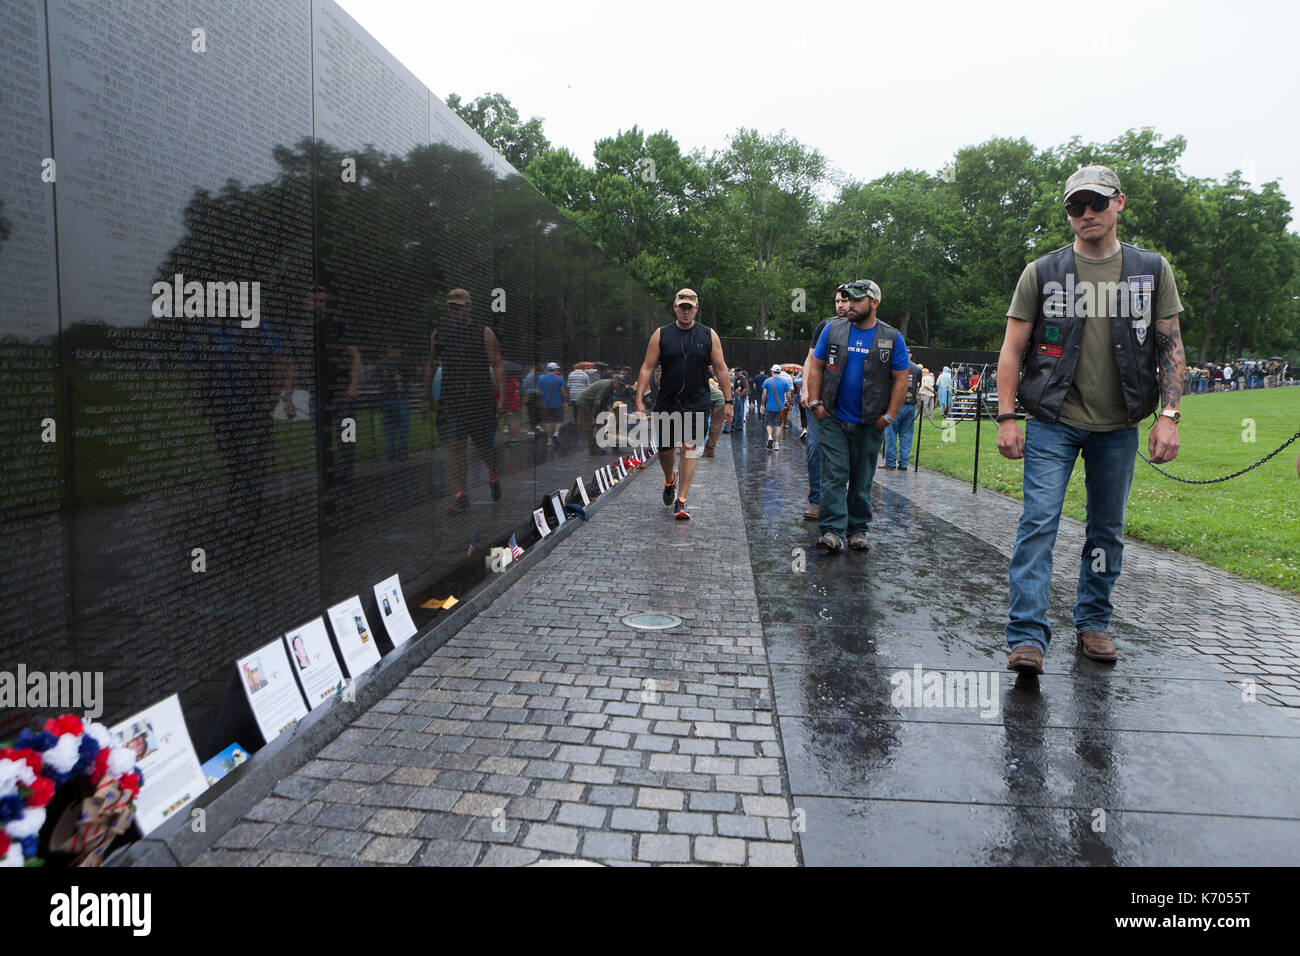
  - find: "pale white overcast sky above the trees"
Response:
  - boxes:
[341,0,1300,217]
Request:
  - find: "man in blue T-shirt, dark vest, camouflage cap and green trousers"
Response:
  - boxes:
[806,280,909,553]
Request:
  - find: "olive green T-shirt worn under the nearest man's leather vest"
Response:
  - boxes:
[1006,250,1183,432]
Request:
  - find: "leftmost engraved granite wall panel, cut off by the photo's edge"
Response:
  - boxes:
[0,0,73,736]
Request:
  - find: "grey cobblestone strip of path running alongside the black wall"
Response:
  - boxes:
[198,444,797,865]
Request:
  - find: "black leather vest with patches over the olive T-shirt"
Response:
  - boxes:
[1017,242,1164,423]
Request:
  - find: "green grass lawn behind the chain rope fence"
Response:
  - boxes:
[920,388,1300,593]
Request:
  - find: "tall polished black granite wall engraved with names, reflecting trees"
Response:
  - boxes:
[0,0,670,757]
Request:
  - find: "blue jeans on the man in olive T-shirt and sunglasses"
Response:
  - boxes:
[1006,419,1138,652]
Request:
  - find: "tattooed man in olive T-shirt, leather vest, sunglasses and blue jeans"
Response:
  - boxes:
[997,165,1187,674]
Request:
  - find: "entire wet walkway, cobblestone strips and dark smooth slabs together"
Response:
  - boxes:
[189,419,1300,865]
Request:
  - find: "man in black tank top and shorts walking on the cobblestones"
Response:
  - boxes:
[637,289,732,520]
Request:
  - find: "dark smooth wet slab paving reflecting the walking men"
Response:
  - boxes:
[731,419,1300,865]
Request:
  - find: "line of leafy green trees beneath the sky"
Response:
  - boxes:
[447,94,1300,362]
